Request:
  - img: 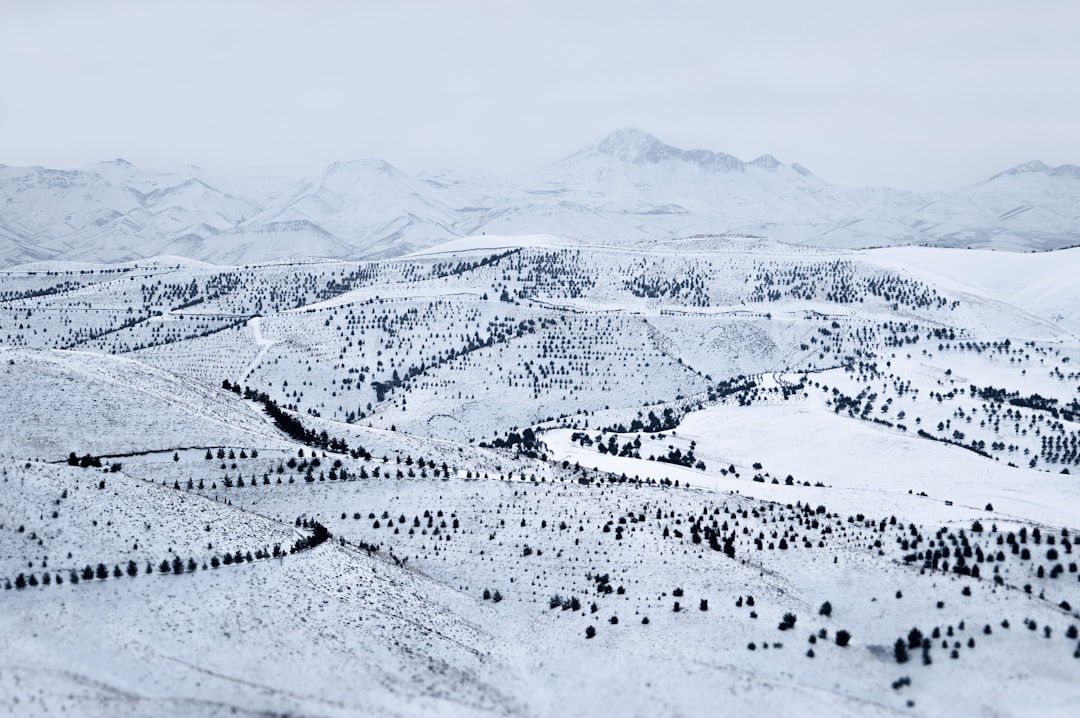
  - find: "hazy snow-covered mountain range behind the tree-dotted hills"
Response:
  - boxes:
[0,127,1080,266]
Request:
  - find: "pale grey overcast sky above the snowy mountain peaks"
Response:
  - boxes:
[0,0,1080,189]
